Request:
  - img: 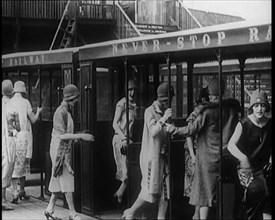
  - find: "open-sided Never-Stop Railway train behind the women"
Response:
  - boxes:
[2,19,272,219]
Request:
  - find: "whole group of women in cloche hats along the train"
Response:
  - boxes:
[2,78,272,220]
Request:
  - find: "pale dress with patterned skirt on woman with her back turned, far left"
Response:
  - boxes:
[11,93,33,178]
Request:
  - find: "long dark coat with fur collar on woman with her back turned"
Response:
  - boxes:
[173,99,240,207]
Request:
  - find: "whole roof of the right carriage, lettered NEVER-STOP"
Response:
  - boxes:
[79,22,272,63]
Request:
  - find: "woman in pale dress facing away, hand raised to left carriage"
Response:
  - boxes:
[11,81,42,204]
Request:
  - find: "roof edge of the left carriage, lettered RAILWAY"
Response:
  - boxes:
[2,48,78,68]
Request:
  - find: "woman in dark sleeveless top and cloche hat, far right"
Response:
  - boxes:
[228,89,272,219]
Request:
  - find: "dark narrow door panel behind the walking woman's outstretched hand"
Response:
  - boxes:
[79,62,96,215]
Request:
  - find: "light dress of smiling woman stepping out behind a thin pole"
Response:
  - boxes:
[113,98,137,181]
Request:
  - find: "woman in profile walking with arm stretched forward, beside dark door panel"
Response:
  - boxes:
[44,84,94,220]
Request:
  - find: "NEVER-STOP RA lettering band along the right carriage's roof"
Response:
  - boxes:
[112,25,272,56]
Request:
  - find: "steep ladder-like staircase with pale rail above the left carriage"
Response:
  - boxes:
[49,0,76,50]
